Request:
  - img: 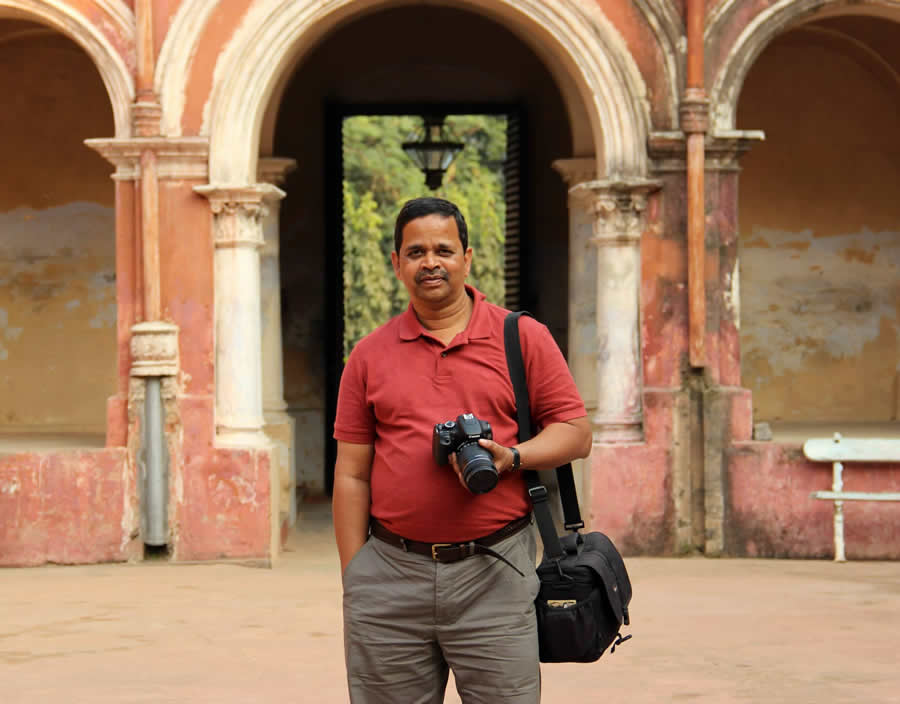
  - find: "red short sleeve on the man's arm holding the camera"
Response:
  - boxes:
[519,316,587,428]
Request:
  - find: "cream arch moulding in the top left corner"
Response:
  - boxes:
[0,0,135,138]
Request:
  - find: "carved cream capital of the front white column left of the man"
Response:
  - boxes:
[194,183,285,247]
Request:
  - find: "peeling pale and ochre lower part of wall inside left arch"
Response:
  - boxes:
[0,202,117,433]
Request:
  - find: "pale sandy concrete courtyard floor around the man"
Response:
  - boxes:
[0,506,900,704]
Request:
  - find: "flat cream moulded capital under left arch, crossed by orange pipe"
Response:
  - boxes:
[84,137,209,181]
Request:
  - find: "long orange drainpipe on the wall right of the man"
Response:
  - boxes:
[679,0,709,367]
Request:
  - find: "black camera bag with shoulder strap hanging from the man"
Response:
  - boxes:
[503,312,631,662]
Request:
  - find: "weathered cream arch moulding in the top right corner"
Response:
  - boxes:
[705,0,900,133]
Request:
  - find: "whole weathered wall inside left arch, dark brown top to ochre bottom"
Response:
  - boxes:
[0,28,116,434]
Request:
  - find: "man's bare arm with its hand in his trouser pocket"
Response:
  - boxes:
[331,440,375,574]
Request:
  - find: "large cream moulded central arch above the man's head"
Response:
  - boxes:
[203,0,650,184]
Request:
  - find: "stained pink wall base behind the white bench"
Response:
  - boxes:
[726,442,900,560]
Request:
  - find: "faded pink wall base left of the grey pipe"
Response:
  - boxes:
[0,448,140,566]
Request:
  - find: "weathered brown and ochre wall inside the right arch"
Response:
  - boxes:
[738,23,900,421]
